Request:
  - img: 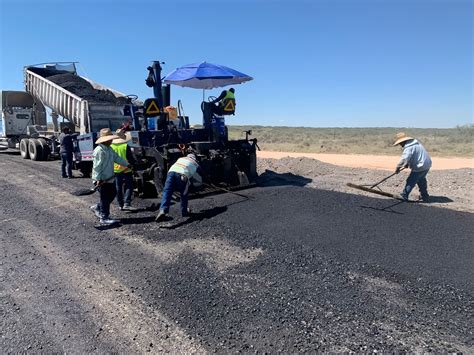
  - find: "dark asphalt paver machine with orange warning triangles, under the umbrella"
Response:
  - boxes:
[131,61,258,196]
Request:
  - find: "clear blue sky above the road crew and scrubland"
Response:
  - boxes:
[0,0,473,127]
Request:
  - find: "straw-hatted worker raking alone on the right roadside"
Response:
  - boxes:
[393,132,431,202]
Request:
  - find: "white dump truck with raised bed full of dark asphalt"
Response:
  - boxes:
[0,62,136,176]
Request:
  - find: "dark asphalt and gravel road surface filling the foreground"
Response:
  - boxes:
[0,153,474,353]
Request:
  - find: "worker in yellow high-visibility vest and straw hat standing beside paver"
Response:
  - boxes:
[111,128,135,211]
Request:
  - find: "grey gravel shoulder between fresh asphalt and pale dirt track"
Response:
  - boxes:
[257,157,474,213]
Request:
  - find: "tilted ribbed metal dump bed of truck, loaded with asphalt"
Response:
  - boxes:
[25,66,129,134]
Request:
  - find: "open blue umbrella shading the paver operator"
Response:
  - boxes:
[163,62,253,90]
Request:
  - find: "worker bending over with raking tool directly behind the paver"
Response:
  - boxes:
[155,153,202,222]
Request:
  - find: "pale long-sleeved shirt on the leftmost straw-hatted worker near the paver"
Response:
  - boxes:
[92,144,128,183]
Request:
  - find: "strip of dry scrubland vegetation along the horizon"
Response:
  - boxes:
[229,125,474,157]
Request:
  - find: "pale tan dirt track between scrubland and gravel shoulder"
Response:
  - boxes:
[258,151,474,170]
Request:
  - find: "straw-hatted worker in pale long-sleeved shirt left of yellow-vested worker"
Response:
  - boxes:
[91,128,130,225]
